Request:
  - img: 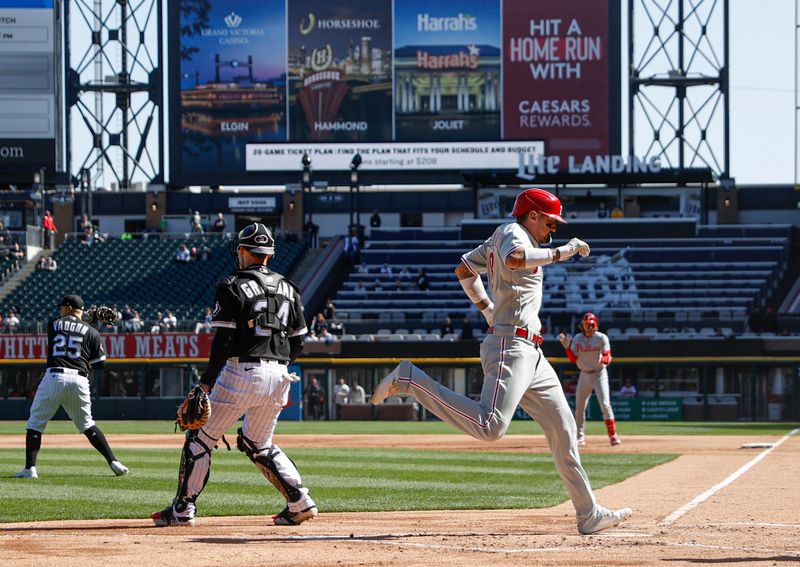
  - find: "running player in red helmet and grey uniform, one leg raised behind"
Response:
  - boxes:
[372,189,631,534]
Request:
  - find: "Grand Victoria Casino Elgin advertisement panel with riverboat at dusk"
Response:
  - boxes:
[173,0,287,183]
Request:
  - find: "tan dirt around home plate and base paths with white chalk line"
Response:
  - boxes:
[0,435,800,567]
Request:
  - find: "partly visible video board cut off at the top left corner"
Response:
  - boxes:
[0,0,57,172]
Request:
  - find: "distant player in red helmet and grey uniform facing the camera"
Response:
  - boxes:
[558,313,622,445]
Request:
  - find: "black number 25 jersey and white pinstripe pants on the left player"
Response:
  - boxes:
[26,315,106,433]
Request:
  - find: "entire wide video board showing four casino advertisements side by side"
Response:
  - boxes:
[167,0,620,185]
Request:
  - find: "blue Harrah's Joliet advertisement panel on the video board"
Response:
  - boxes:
[394,0,502,141]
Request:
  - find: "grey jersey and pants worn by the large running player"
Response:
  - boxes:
[382,223,596,520]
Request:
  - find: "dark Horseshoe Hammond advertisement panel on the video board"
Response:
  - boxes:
[288,0,392,141]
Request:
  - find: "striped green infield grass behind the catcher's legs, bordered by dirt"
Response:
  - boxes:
[0,448,675,523]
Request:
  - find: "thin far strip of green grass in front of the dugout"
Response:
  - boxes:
[0,420,800,436]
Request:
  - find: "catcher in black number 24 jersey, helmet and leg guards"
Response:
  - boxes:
[151,223,317,527]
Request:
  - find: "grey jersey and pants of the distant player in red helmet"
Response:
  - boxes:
[569,331,614,439]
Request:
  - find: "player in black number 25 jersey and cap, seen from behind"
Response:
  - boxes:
[16,295,128,478]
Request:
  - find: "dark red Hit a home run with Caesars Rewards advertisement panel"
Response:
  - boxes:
[503,0,618,161]
